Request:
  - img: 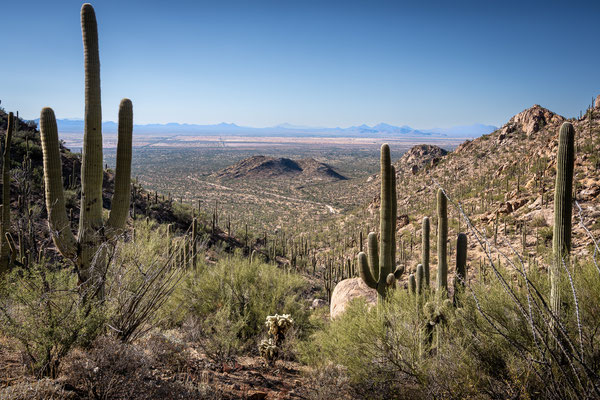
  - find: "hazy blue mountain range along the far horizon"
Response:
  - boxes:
[36,119,498,138]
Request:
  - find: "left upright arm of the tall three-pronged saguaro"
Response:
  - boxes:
[40,108,77,258]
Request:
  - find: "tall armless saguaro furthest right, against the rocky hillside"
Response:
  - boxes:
[550,122,575,328]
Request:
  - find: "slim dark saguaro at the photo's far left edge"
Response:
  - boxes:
[0,113,15,273]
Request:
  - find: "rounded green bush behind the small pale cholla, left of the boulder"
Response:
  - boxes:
[164,257,308,352]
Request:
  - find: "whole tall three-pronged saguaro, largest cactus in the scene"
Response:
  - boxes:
[40,4,133,282]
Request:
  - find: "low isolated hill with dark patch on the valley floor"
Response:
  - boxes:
[214,156,346,181]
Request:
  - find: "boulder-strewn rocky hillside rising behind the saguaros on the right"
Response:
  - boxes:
[354,97,600,290]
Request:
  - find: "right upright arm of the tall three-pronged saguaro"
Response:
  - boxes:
[107,99,133,233]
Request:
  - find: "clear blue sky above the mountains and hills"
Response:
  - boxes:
[0,0,600,128]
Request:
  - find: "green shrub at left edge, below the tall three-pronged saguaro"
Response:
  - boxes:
[0,263,105,377]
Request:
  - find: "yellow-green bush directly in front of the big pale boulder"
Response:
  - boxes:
[300,290,432,399]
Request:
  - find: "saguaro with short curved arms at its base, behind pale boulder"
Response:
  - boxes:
[358,144,402,298]
